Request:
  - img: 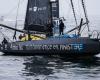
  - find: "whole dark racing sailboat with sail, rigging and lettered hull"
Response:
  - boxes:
[0,0,100,57]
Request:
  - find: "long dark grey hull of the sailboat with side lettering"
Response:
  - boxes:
[0,38,100,57]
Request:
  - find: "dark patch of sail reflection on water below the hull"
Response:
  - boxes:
[23,57,53,76]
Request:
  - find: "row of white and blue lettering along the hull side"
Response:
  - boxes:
[11,44,84,51]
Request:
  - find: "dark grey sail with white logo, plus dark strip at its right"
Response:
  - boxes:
[24,0,59,32]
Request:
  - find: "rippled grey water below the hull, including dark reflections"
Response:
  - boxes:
[0,55,100,80]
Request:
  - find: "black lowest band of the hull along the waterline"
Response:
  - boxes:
[2,51,99,58]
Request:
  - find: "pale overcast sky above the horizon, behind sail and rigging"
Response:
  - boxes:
[0,0,100,15]
